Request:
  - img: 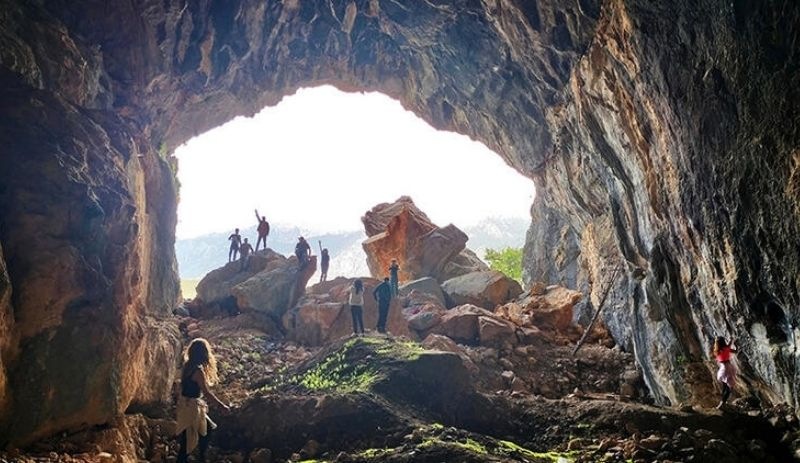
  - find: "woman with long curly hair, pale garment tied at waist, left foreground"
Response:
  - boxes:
[175,338,230,463]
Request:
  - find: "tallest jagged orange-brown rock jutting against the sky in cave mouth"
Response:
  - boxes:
[361,196,486,282]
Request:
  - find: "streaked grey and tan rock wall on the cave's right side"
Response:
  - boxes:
[526,1,800,403]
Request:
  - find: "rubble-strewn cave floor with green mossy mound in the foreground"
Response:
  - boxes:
[0,306,800,463]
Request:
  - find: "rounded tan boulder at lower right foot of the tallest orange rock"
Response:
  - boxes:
[442,270,522,310]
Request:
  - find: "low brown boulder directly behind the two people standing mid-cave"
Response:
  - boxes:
[283,277,411,346]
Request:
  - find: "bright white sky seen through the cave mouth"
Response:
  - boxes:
[174,86,534,238]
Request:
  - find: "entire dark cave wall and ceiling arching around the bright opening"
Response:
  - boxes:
[0,0,800,445]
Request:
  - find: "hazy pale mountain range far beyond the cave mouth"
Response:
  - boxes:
[175,218,528,279]
